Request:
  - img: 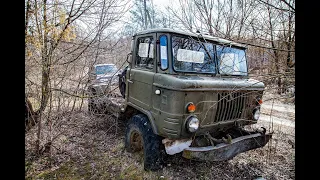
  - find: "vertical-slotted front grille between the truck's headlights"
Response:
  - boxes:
[214,92,248,122]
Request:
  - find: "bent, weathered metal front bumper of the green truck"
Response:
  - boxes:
[182,133,272,161]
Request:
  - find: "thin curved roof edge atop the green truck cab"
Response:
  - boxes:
[133,28,246,48]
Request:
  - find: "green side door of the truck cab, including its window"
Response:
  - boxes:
[127,34,156,110]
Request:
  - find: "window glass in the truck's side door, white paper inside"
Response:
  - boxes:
[135,37,154,69]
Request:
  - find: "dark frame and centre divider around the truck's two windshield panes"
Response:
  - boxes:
[168,33,249,77]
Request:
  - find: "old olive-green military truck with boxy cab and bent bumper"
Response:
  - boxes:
[89,29,272,170]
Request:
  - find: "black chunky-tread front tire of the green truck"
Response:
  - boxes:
[125,114,165,171]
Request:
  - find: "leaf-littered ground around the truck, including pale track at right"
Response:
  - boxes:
[25,93,295,179]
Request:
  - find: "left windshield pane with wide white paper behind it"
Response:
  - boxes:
[172,36,216,73]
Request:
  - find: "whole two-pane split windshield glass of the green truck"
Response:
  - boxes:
[172,36,247,75]
